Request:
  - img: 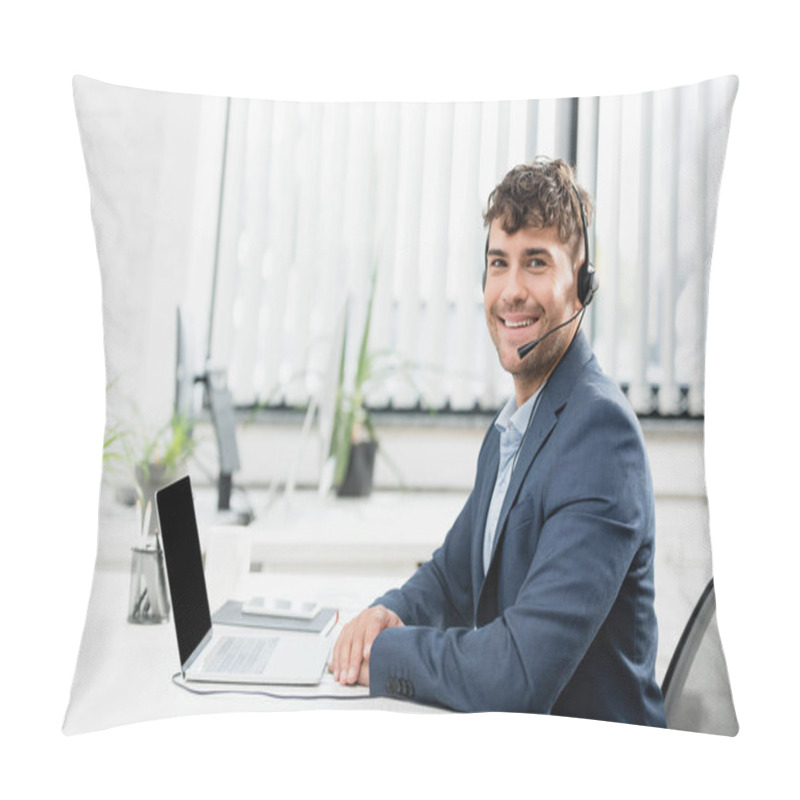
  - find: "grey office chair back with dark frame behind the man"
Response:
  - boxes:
[661,578,739,736]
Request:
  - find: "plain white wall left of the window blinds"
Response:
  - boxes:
[74,78,224,444]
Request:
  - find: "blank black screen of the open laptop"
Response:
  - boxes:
[156,475,211,664]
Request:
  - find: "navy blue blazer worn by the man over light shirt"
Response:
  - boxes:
[369,333,665,726]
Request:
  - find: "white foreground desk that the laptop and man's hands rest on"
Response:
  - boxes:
[64,569,450,733]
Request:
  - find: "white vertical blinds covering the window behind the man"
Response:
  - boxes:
[209,82,726,415]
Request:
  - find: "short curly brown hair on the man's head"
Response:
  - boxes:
[483,156,594,244]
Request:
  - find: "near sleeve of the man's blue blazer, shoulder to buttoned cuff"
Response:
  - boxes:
[370,398,653,713]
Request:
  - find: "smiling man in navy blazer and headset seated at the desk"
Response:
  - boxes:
[330,158,665,726]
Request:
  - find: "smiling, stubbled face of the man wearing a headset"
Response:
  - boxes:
[484,220,581,405]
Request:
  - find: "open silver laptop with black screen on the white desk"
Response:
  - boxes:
[156,475,332,686]
